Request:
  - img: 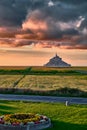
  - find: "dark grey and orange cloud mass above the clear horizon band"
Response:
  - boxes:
[0,0,87,49]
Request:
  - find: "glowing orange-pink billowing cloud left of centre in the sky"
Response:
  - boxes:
[22,10,48,39]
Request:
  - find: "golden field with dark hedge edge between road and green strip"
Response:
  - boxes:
[0,75,87,97]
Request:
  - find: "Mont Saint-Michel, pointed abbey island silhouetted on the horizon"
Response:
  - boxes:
[44,54,71,67]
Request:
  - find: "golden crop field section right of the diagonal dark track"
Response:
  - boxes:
[17,75,87,91]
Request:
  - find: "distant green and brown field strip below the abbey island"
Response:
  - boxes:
[0,67,87,75]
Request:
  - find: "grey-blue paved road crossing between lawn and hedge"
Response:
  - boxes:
[0,94,87,104]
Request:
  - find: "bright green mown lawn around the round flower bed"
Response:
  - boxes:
[0,101,87,130]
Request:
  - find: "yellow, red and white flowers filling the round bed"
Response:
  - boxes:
[0,113,48,125]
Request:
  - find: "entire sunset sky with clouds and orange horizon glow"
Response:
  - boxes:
[0,0,87,66]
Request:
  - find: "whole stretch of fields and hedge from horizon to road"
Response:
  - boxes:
[0,67,87,97]
